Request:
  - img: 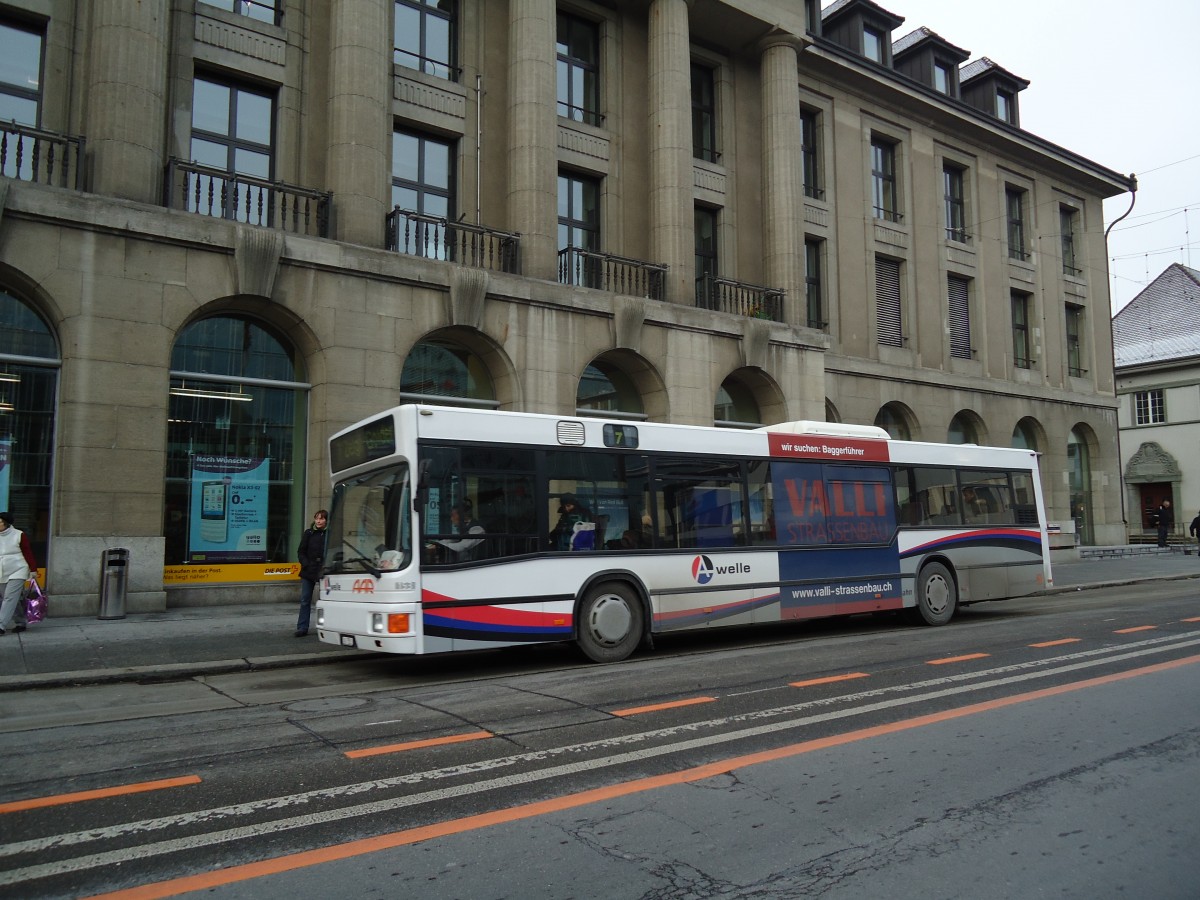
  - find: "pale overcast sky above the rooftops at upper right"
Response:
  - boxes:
[883,0,1200,312]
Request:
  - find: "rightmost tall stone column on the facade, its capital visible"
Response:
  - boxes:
[762,35,806,325]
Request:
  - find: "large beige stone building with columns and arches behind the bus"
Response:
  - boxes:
[0,0,1130,614]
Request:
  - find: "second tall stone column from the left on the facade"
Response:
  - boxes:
[325,0,391,247]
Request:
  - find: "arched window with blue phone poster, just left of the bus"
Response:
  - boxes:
[163,316,310,571]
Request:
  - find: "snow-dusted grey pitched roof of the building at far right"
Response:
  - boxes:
[1112,263,1200,368]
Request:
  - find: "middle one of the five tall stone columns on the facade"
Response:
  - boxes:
[508,0,558,281]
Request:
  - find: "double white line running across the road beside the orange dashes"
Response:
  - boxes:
[0,636,1200,886]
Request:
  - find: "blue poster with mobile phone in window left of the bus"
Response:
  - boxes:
[187,454,270,564]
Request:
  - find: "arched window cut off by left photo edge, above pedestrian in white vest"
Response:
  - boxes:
[0,289,59,566]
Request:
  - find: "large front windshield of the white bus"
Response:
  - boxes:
[324,463,413,576]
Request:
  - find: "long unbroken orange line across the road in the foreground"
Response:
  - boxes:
[88,655,1200,900]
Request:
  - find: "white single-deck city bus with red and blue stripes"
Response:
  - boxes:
[316,403,1051,662]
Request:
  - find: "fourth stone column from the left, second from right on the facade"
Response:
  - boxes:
[647,0,696,304]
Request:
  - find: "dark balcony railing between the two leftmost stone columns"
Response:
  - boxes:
[163,158,334,238]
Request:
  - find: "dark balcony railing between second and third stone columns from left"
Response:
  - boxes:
[386,206,521,275]
